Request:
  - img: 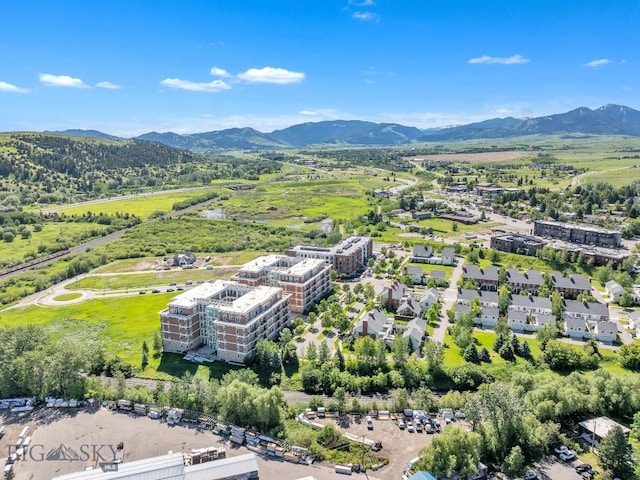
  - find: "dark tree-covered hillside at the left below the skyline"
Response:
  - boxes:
[0,133,280,206]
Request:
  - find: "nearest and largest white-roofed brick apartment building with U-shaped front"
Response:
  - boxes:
[160,280,290,363]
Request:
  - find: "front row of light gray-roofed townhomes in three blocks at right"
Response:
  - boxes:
[454,289,617,343]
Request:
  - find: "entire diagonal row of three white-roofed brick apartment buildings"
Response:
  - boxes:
[160,237,373,363]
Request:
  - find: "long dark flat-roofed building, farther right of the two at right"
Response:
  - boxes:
[533,220,622,248]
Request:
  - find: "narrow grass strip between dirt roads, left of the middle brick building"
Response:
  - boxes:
[67,267,238,290]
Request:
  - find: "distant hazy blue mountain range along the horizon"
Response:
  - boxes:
[55,104,640,152]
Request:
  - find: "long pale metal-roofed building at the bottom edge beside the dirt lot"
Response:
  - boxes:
[53,453,260,480]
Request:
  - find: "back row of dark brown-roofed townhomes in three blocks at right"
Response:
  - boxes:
[462,265,591,299]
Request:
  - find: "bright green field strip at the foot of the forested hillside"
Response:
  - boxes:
[50,188,221,220]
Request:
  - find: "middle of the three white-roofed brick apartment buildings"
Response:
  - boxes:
[233,255,331,313]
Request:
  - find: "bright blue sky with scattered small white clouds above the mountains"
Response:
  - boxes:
[0,0,640,136]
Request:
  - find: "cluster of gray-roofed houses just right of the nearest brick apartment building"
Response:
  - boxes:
[353,280,439,351]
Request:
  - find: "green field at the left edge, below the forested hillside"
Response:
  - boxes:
[0,223,106,262]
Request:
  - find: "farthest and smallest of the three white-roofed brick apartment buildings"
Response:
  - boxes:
[285,236,373,277]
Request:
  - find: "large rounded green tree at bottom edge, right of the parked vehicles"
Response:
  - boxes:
[417,427,480,477]
